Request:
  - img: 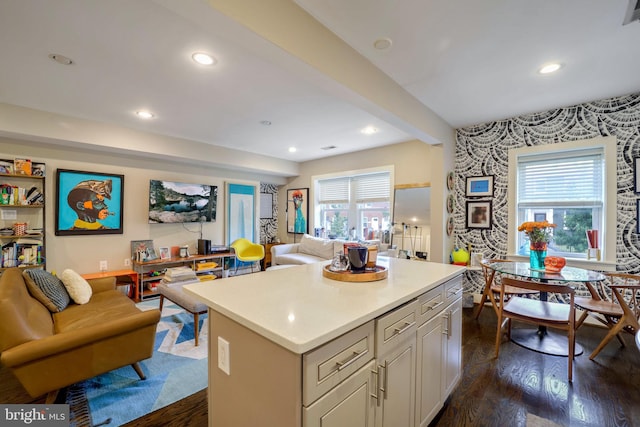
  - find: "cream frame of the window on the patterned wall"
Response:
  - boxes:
[507,136,617,270]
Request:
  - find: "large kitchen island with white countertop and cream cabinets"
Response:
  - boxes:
[184,257,464,427]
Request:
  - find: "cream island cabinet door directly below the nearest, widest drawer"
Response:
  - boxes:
[302,360,377,427]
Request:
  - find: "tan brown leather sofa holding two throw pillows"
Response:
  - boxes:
[0,268,160,401]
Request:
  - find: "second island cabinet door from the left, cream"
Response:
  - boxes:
[376,332,416,427]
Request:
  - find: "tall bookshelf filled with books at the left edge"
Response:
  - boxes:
[0,163,46,274]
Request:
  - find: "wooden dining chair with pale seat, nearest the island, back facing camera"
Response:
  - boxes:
[496,277,576,382]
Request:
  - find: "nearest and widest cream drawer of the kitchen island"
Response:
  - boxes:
[302,320,374,406]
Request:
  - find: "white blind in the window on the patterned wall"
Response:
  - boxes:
[518,150,604,208]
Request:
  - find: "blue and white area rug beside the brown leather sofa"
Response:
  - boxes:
[77,300,208,427]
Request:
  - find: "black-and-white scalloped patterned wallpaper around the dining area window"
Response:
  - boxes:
[455,93,640,293]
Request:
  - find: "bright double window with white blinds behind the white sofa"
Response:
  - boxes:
[314,170,391,240]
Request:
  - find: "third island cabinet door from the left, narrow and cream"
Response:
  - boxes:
[415,314,446,427]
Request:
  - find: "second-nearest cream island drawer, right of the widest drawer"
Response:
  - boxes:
[376,299,418,356]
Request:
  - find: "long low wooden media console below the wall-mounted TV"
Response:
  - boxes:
[133,252,236,302]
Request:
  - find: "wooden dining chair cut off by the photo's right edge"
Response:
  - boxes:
[576,273,640,360]
